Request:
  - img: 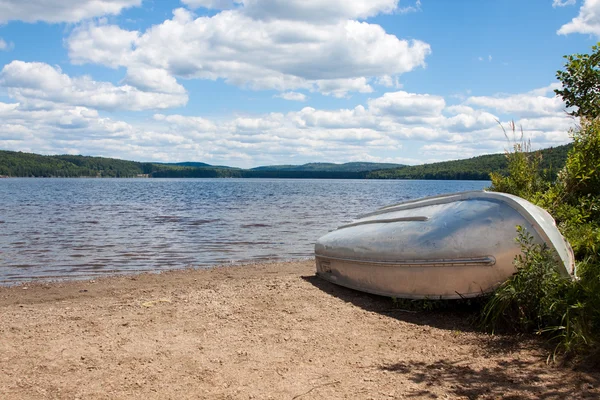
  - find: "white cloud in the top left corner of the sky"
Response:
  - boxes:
[0,0,142,23]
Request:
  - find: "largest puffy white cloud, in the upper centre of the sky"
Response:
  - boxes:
[67,7,431,97]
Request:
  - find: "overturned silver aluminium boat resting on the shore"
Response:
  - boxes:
[315,191,574,299]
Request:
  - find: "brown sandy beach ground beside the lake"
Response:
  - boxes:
[0,261,600,400]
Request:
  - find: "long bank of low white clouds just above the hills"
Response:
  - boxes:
[0,83,576,167]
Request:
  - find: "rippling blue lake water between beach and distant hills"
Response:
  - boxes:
[0,178,490,285]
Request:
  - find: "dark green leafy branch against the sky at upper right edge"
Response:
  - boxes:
[554,45,600,118]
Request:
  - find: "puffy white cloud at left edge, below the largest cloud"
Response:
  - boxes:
[0,61,187,110]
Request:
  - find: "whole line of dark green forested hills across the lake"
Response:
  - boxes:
[0,145,571,180]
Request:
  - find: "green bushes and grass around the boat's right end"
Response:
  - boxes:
[482,113,600,358]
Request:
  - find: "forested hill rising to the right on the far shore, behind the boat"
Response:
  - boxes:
[365,144,572,180]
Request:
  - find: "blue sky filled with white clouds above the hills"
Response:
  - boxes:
[0,0,600,168]
